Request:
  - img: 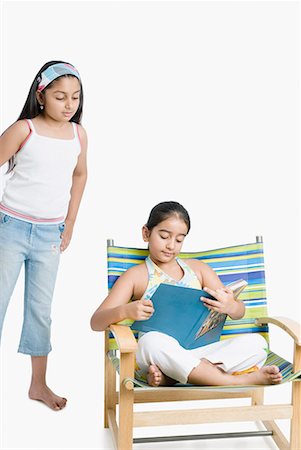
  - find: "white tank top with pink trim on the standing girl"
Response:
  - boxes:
[0,120,81,222]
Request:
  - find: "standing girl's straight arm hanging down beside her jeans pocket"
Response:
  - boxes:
[60,126,88,252]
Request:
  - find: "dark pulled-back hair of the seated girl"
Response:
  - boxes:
[145,202,190,233]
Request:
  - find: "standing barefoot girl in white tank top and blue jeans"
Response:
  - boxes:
[0,61,87,410]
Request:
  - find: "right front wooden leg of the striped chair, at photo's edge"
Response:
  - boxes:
[290,344,301,450]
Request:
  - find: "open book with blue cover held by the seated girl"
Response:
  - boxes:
[131,280,248,349]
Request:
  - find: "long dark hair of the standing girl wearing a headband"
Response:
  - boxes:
[6,61,84,173]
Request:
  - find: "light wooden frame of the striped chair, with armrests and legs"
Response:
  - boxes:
[104,237,301,450]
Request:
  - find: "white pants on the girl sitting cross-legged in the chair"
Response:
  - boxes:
[136,331,268,383]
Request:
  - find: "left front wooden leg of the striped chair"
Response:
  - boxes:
[118,353,135,450]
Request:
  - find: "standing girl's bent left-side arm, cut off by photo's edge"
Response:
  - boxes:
[0,120,30,167]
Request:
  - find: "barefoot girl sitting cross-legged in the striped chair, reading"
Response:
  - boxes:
[91,202,281,386]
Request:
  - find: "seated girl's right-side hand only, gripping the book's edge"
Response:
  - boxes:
[201,287,238,318]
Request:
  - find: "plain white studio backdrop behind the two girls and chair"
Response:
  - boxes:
[1,1,300,449]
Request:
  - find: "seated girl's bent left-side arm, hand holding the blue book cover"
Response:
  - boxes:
[91,267,154,331]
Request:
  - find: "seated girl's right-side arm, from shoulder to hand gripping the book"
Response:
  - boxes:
[190,261,245,320]
